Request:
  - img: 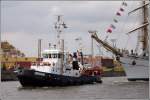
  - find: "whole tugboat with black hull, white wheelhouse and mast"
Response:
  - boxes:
[17,16,102,87]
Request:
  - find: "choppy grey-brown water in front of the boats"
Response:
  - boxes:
[0,77,149,100]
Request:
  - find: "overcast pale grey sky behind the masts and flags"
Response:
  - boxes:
[1,1,143,56]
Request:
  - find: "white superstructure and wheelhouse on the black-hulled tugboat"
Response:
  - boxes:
[31,49,83,77]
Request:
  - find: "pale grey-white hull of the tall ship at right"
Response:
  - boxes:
[120,57,149,81]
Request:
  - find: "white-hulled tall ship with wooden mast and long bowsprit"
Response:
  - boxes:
[91,1,149,81]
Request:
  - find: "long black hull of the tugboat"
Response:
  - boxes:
[17,69,102,87]
